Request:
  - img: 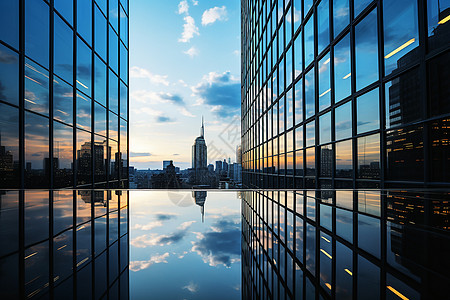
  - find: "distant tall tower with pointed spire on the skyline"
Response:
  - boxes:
[192,117,208,184]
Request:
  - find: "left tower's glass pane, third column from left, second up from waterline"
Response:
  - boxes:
[53,77,73,125]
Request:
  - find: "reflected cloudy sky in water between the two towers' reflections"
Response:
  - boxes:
[130,192,241,299]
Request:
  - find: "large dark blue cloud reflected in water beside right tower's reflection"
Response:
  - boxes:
[191,220,241,267]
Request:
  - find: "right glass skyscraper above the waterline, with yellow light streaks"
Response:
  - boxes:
[241,0,450,188]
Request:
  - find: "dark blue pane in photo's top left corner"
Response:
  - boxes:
[0,1,19,49]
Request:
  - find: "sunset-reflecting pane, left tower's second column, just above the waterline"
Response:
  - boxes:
[25,112,50,188]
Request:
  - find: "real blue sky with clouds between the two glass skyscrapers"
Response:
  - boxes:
[129,0,240,169]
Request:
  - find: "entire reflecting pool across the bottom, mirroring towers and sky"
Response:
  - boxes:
[0,190,450,300]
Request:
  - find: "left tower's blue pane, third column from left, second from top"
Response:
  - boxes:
[53,15,73,83]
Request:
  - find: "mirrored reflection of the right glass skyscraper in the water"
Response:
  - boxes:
[241,189,450,299]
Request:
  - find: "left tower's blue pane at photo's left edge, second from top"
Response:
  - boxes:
[0,44,19,105]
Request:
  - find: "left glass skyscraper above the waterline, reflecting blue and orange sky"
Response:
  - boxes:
[0,0,129,188]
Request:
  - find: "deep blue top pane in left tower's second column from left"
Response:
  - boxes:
[25,0,50,69]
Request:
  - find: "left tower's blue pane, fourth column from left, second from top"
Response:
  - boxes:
[77,38,92,95]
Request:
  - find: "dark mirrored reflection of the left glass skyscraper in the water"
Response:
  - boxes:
[0,190,130,299]
